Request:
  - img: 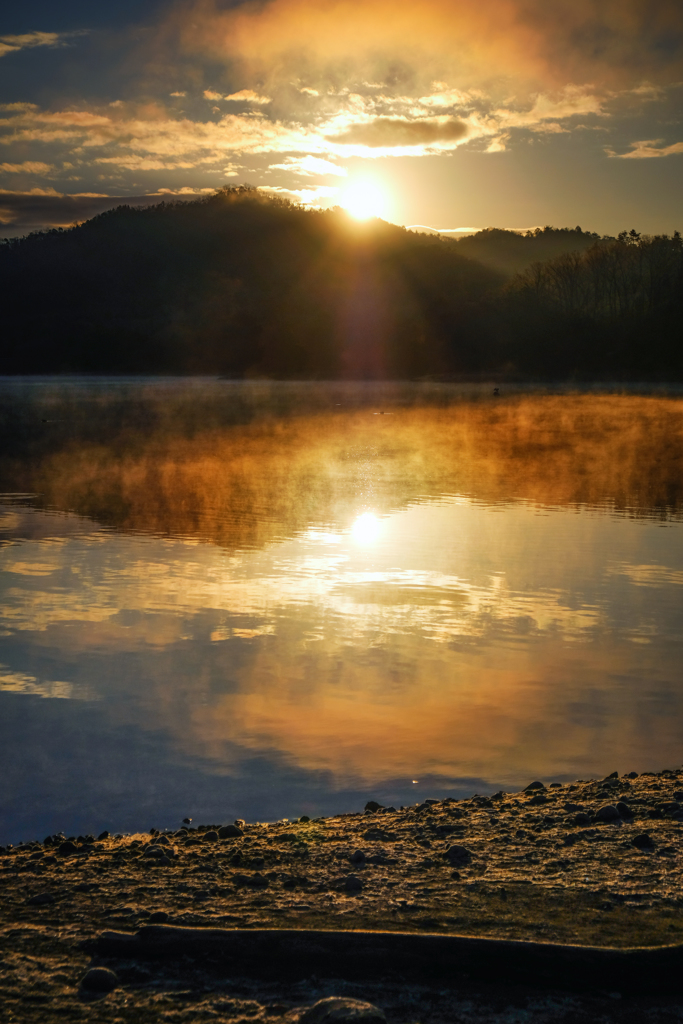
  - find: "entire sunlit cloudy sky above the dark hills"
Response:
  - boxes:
[0,0,683,237]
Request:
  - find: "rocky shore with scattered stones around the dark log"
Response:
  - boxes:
[0,769,683,1024]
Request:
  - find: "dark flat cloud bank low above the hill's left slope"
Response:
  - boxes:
[0,189,198,239]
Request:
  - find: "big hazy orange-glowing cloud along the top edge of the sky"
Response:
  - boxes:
[171,0,683,91]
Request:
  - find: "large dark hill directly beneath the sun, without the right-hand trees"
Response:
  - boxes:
[0,186,502,378]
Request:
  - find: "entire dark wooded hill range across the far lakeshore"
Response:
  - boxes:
[0,186,683,380]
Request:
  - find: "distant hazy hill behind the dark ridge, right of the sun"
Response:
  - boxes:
[454,227,600,276]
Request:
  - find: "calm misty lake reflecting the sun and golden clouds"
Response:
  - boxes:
[0,379,683,843]
